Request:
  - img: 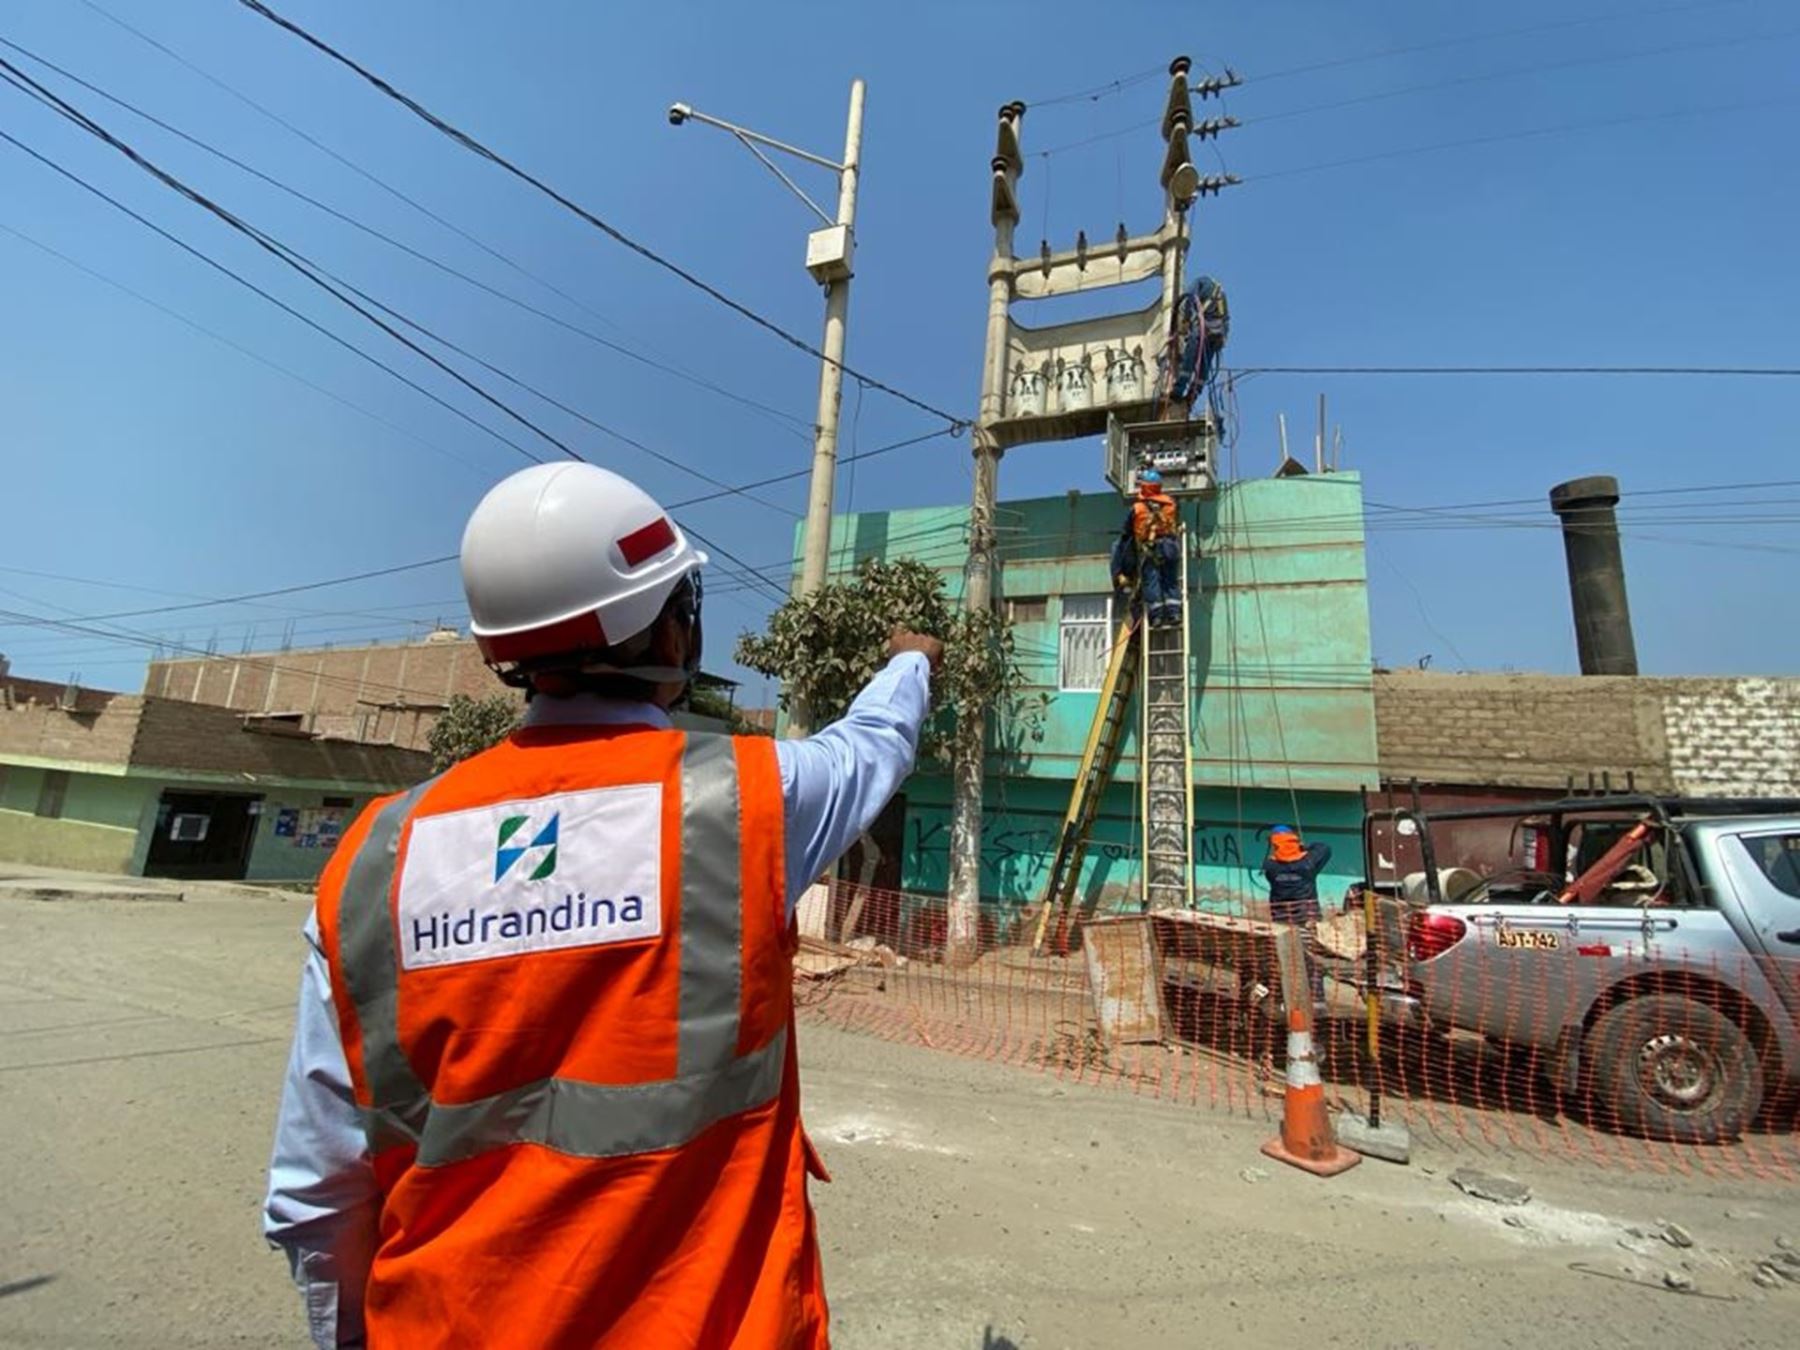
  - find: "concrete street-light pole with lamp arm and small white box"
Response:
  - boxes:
[670,79,864,736]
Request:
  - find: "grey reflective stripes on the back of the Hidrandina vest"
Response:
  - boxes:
[340,734,787,1166]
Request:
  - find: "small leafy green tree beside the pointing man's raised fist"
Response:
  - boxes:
[736,558,1049,963]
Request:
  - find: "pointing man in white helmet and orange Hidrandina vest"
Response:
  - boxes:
[265,464,943,1350]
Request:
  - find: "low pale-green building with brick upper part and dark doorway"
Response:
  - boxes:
[0,680,430,882]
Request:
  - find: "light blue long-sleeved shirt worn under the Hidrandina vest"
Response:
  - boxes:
[263,652,931,1350]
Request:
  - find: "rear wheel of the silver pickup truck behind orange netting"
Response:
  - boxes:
[1584,994,1762,1143]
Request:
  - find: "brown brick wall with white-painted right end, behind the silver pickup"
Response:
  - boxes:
[1375,671,1800,796]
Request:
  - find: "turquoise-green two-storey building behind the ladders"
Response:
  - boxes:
[802,473,1377,911]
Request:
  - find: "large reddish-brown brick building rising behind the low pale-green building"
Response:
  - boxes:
[144,639,506,751]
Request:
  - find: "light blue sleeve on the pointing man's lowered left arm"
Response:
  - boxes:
[263,914,380,1350]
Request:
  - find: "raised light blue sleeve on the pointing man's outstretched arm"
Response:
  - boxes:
[776,652,931,914]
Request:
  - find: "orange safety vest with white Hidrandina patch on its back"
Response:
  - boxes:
[319,727,828,1350]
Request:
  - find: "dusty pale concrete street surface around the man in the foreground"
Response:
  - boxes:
[0,887,1800,1350]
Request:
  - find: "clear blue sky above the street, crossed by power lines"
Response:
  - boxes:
[0,0,1800,689]
